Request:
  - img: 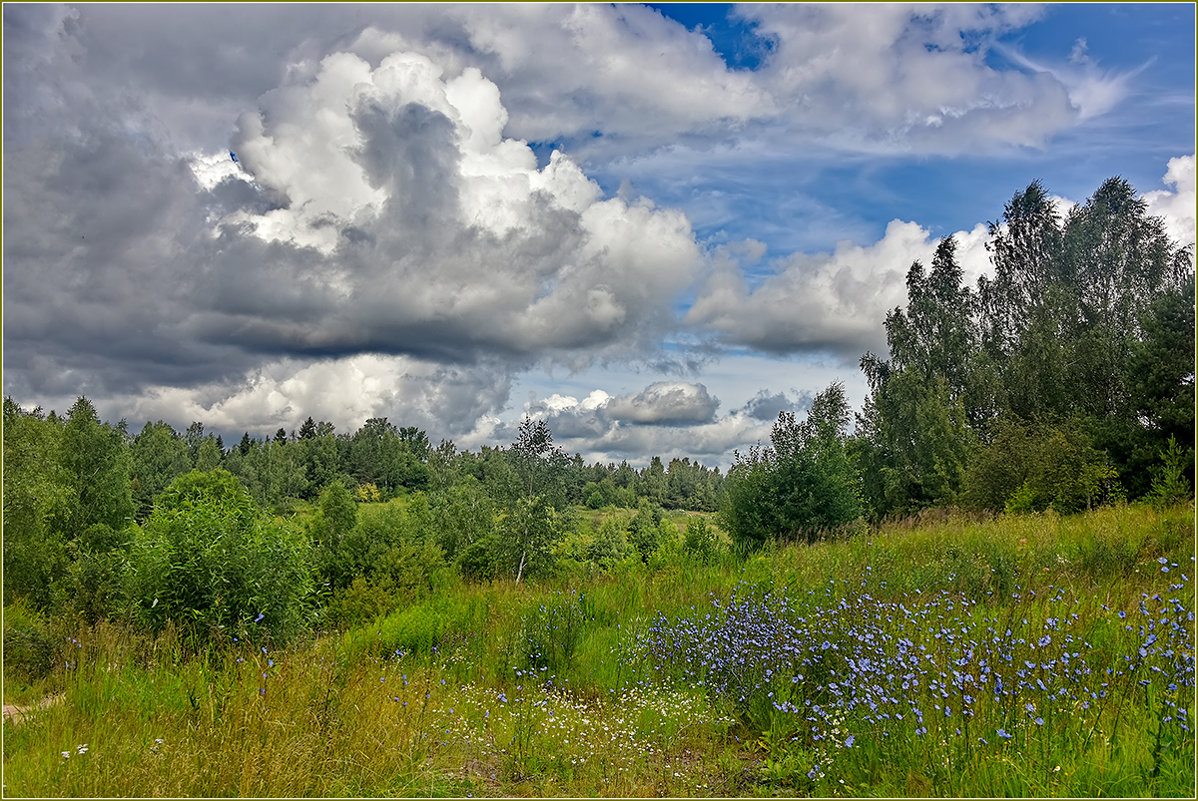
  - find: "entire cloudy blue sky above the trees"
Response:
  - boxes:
[2,2,1196,468]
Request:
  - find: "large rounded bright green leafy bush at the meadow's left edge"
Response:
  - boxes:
[131,469,311,639]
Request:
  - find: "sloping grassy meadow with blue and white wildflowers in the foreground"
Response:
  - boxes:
[4,505,1196,797]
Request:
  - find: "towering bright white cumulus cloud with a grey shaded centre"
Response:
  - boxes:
[192,45,701,360]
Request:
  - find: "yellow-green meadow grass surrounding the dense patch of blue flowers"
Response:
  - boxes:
[4,506,1194,797]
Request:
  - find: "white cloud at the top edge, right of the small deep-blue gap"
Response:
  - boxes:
[738,4,1077,153]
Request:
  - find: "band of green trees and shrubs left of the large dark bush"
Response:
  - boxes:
[4,398,722,636]
